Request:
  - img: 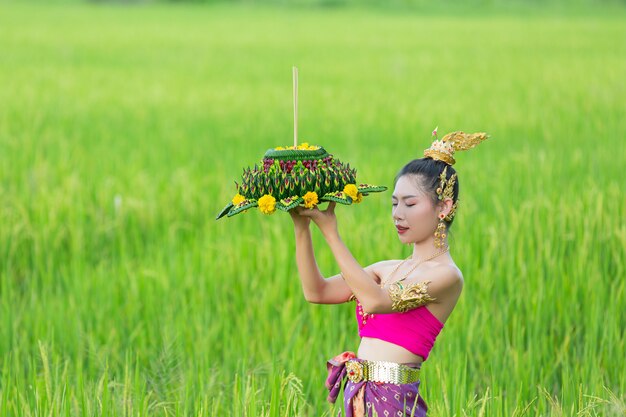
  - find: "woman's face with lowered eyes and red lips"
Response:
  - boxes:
[391,175,440,243]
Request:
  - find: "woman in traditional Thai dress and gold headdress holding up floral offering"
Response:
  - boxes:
[290,129,487,417]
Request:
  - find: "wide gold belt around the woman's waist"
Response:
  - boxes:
[346,360,420,384]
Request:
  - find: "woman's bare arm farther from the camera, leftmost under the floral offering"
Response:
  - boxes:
[289,210,352,304]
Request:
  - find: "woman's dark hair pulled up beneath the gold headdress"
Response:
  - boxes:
[393,158,459,227]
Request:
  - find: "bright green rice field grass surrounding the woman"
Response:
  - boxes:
[0,3,626,417]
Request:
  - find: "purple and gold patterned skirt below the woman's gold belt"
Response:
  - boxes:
[326,352,428,417]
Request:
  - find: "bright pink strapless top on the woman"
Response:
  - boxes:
[355,302,443,360]
